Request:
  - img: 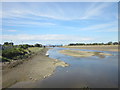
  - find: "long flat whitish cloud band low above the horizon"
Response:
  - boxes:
[1,34,93,41]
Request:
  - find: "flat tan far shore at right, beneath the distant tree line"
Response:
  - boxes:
[64,45,120,52]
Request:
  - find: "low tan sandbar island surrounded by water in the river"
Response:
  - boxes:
[59,50,112,58]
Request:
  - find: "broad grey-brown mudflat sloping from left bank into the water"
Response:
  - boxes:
[2,49,68,88]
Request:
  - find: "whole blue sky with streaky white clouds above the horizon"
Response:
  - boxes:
[2,2,118,44]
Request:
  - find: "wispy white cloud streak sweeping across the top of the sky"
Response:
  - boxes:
[3,3,113,20]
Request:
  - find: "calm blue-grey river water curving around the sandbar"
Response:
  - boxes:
[37,48,118,88]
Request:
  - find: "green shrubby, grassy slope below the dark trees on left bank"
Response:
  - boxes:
[0,47,43,62]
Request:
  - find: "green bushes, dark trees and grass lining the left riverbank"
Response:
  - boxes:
[0,42,42,62]
